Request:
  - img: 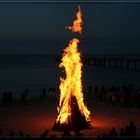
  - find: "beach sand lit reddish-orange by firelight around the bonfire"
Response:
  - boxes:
[0,99,140,136]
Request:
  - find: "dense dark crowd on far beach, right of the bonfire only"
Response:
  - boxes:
[88,85,140,108]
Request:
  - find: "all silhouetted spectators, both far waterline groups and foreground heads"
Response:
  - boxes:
[0,85,140,137]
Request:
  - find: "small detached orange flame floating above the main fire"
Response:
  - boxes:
[66,6,83,33]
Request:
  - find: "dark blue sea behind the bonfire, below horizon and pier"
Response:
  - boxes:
[0,55,140,99]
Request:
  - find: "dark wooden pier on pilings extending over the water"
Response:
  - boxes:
[88,54,140,71]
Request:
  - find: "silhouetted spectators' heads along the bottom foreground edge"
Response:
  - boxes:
[0,121,137,138]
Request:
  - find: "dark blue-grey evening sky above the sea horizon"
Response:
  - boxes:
[0,2,140,54]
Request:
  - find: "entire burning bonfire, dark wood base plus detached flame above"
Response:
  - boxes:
[53,6,91,132]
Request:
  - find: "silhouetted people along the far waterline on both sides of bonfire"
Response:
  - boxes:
[2,85,140,108]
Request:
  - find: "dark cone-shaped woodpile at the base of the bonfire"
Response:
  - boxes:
[53,96,91,131]
